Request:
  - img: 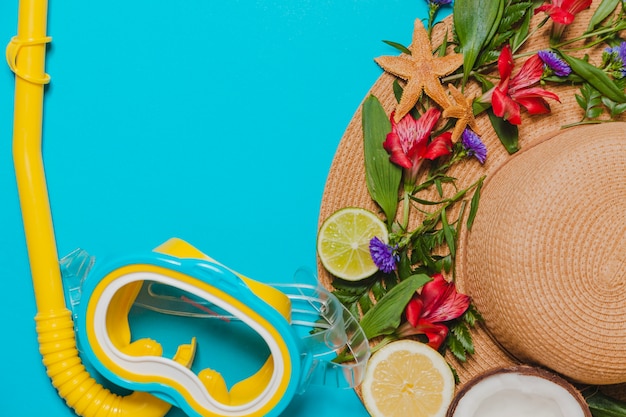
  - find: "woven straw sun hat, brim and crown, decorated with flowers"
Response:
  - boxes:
[318,0,626,399]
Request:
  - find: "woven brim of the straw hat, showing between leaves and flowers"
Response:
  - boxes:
[318,1,626,399]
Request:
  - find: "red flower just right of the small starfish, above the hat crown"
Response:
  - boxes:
[491,45,559,125]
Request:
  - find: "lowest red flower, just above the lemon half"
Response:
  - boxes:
[398,274,470,349]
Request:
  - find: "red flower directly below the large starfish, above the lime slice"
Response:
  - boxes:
[383,108,452,186]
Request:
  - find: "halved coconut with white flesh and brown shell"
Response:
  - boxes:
[446,366,591,417]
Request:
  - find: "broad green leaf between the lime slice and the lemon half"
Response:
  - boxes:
[361,274,431,339]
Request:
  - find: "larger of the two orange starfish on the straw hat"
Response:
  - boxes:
[375,19,463,122]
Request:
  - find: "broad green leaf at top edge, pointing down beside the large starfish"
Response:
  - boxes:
[453,0,504,84]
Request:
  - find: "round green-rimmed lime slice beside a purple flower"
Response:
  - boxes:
[317,207,389,281]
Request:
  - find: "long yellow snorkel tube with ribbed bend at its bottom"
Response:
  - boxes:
[6,0,171,417]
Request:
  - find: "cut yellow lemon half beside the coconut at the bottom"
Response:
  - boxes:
[361,340,454,417]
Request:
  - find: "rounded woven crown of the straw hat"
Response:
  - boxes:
[459,123,626,384]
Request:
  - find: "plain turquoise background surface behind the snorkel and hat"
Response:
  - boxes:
[0,0,449,417]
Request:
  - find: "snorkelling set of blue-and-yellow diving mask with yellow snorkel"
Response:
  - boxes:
[6,0,370,417]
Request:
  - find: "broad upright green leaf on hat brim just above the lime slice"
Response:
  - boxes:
[363,96,402,224]
